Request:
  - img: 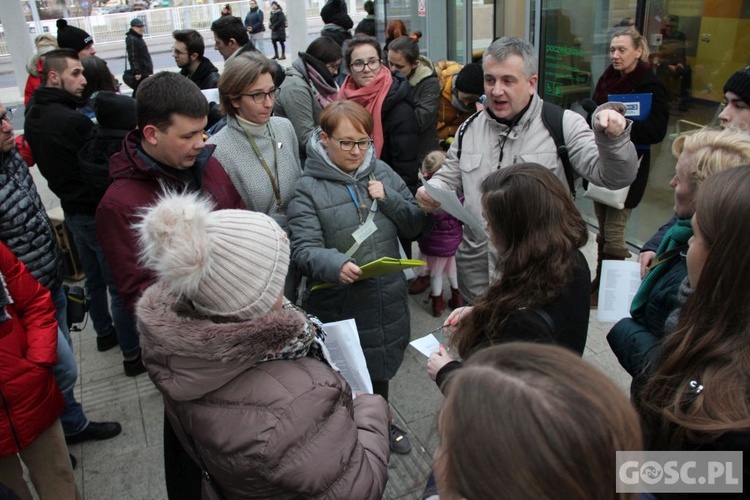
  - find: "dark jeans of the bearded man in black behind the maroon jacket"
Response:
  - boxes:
[65,214,141,358]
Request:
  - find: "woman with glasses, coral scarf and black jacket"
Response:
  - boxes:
[339,36,419,194]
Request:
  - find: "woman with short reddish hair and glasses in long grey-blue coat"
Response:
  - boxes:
[289,101,427,453]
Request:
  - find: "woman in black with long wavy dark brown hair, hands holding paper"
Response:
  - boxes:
[428,163,590,387]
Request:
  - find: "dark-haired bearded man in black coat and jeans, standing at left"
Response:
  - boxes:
[24,49,146,376]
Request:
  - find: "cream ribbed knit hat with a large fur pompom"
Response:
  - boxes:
[136,192,289,321]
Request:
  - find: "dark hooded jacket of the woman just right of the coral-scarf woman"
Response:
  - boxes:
[409,56,440,164]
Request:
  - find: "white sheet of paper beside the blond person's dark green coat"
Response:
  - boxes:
[596,260,641,323]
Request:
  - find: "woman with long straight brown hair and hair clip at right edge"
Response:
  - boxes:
[636,165,750,484]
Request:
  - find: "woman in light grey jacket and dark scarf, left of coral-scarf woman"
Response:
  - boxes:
[274,37,343,163]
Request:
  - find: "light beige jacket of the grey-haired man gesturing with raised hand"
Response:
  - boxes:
[429,94,638,301]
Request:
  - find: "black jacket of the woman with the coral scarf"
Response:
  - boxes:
[380,72,419,194]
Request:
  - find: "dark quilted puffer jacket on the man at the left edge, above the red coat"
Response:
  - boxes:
[0,149,62,290]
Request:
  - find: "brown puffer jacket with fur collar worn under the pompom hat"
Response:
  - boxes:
[137,290,389,499]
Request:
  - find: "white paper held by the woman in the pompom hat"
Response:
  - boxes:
[323,319,372,394]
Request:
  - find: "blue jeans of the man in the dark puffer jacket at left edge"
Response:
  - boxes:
[52,285,89,436]
